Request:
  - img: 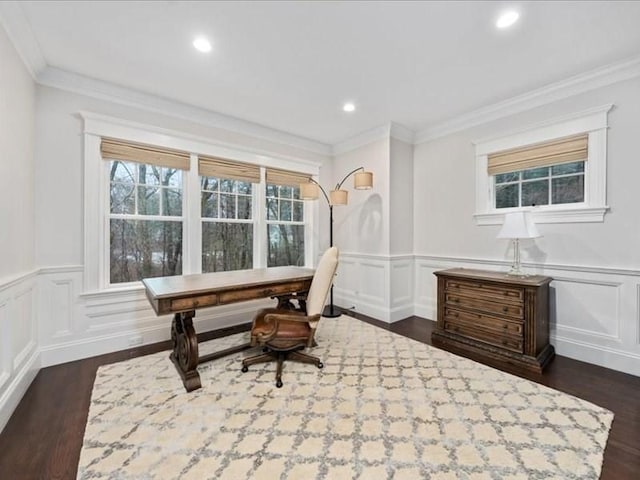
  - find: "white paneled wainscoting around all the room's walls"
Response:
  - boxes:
[0,253,640,430]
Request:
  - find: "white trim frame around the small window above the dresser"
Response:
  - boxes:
[473,104,613,225]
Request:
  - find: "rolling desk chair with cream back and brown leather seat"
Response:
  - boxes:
[242,247,338,388]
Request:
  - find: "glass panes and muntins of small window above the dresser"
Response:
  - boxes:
[493,161,585,209]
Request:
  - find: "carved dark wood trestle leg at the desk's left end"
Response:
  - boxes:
[169,310,202,392]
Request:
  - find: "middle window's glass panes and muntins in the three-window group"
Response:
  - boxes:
[200,176,254,273]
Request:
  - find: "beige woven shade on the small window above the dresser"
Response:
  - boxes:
[488,134,588,175]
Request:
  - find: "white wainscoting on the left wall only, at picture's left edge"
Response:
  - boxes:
[0,272,40,430]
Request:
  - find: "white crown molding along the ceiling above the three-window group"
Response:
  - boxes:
[37,67,331,156]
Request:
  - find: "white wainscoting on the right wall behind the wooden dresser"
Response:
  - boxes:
[414,255,640,376]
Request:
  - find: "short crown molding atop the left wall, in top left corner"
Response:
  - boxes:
[0,2,47,80]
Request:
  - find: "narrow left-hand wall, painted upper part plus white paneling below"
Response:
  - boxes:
[0,23,39,430]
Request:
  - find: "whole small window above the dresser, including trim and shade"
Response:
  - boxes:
[475,105,612,225]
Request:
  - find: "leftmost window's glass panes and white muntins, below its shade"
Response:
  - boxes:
[108,160,183,284]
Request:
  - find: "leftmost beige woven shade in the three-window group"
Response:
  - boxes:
[100,138,189,170]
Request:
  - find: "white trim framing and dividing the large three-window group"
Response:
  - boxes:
[79,112,321,295]
